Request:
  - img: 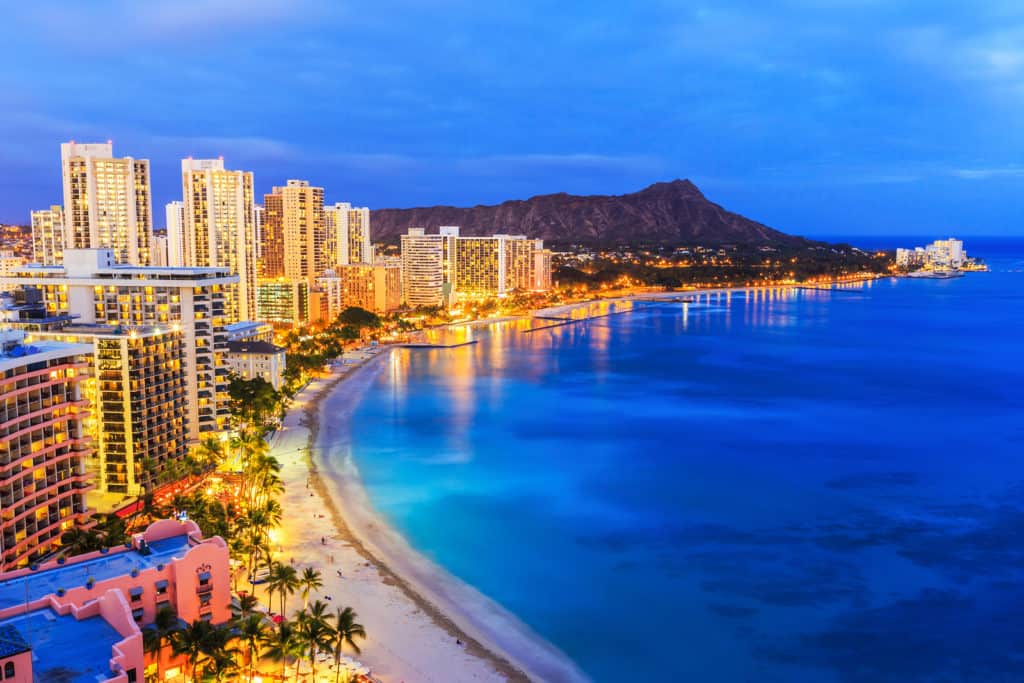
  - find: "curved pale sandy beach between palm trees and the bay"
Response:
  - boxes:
[268,349,587,683]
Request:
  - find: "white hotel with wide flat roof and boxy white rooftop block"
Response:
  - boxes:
[7,249,239,441]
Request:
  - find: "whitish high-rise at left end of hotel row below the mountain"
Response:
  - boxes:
[401,226,459,307]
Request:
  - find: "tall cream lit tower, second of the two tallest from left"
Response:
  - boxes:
[181,159,256,321]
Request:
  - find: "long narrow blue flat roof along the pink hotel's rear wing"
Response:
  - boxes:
[0,531,189,609]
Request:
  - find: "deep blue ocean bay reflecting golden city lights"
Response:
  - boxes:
[352,242,1024,682]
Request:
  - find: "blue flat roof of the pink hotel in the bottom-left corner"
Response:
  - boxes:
[0,608,124,683]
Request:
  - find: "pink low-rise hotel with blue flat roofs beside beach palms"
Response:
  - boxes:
[0,519,231,683]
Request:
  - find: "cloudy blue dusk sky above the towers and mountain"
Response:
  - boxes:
[0,0,1024,237]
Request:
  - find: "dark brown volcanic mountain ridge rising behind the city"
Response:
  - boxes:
[371,180,804,244]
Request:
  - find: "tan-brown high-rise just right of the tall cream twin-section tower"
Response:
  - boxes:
[263,180,331,286]
